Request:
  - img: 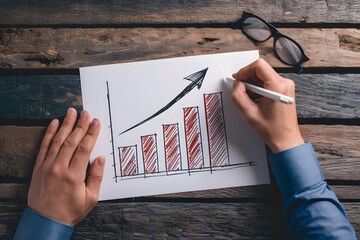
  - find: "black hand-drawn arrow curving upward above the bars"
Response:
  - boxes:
[119,68,208,135]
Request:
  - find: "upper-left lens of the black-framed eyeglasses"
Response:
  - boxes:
[243,17,271,42]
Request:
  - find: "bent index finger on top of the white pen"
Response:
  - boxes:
[232,58,280,82]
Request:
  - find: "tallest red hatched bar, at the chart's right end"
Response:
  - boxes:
[204,93,229,167]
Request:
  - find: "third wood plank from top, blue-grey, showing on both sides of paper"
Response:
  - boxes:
[0,74,360,119]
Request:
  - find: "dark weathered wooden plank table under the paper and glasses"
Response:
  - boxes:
[0,0,360,239]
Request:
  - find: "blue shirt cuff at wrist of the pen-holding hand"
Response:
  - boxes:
[268,143,324,199]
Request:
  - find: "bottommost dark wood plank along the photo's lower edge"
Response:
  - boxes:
[0,202,360,239]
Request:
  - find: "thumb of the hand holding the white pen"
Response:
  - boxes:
[231,81,259,122]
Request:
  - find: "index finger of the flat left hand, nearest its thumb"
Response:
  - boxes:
[70,118,100,173]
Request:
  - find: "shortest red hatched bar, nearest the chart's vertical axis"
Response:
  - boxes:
[119,145,138,177]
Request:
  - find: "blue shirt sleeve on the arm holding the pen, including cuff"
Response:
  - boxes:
[268,143,356,240]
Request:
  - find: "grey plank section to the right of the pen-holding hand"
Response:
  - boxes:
[281,74,360,118]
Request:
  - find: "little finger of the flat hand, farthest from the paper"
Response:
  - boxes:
[35,119,59,168]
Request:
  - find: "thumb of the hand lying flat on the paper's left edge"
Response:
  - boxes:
[86,157,106,206]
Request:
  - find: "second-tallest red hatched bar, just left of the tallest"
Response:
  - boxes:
[184,107,204,169]
